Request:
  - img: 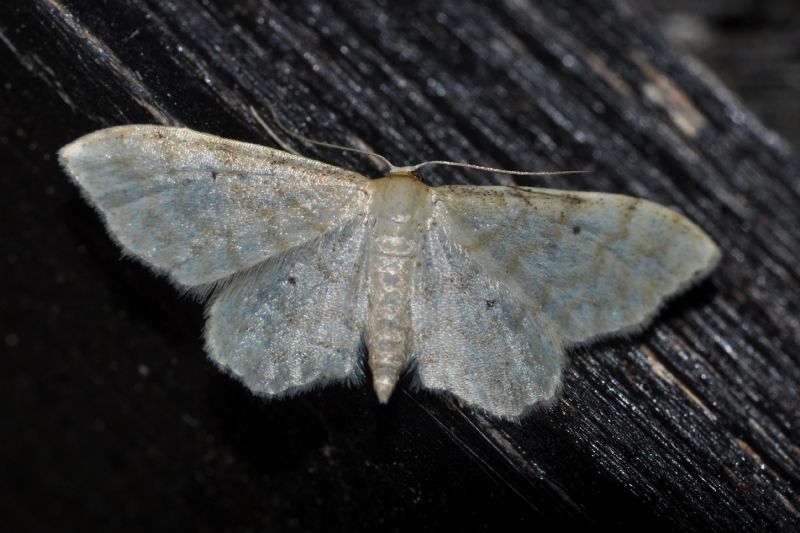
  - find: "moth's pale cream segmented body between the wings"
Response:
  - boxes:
[367,174,432,402]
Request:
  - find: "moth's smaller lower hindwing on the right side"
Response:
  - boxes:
[411,222,564,419]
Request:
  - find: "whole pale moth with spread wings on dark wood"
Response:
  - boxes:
[60,113,719,419]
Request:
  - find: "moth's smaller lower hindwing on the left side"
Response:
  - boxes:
[206,219,367,396]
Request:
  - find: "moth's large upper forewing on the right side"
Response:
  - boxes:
[434,186,719,345]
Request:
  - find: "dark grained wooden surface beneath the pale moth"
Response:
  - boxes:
[0,0,800,531]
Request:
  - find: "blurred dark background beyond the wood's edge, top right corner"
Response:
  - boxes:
[631,0,800,151]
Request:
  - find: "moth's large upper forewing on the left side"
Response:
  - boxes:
[60,126,369,287]
